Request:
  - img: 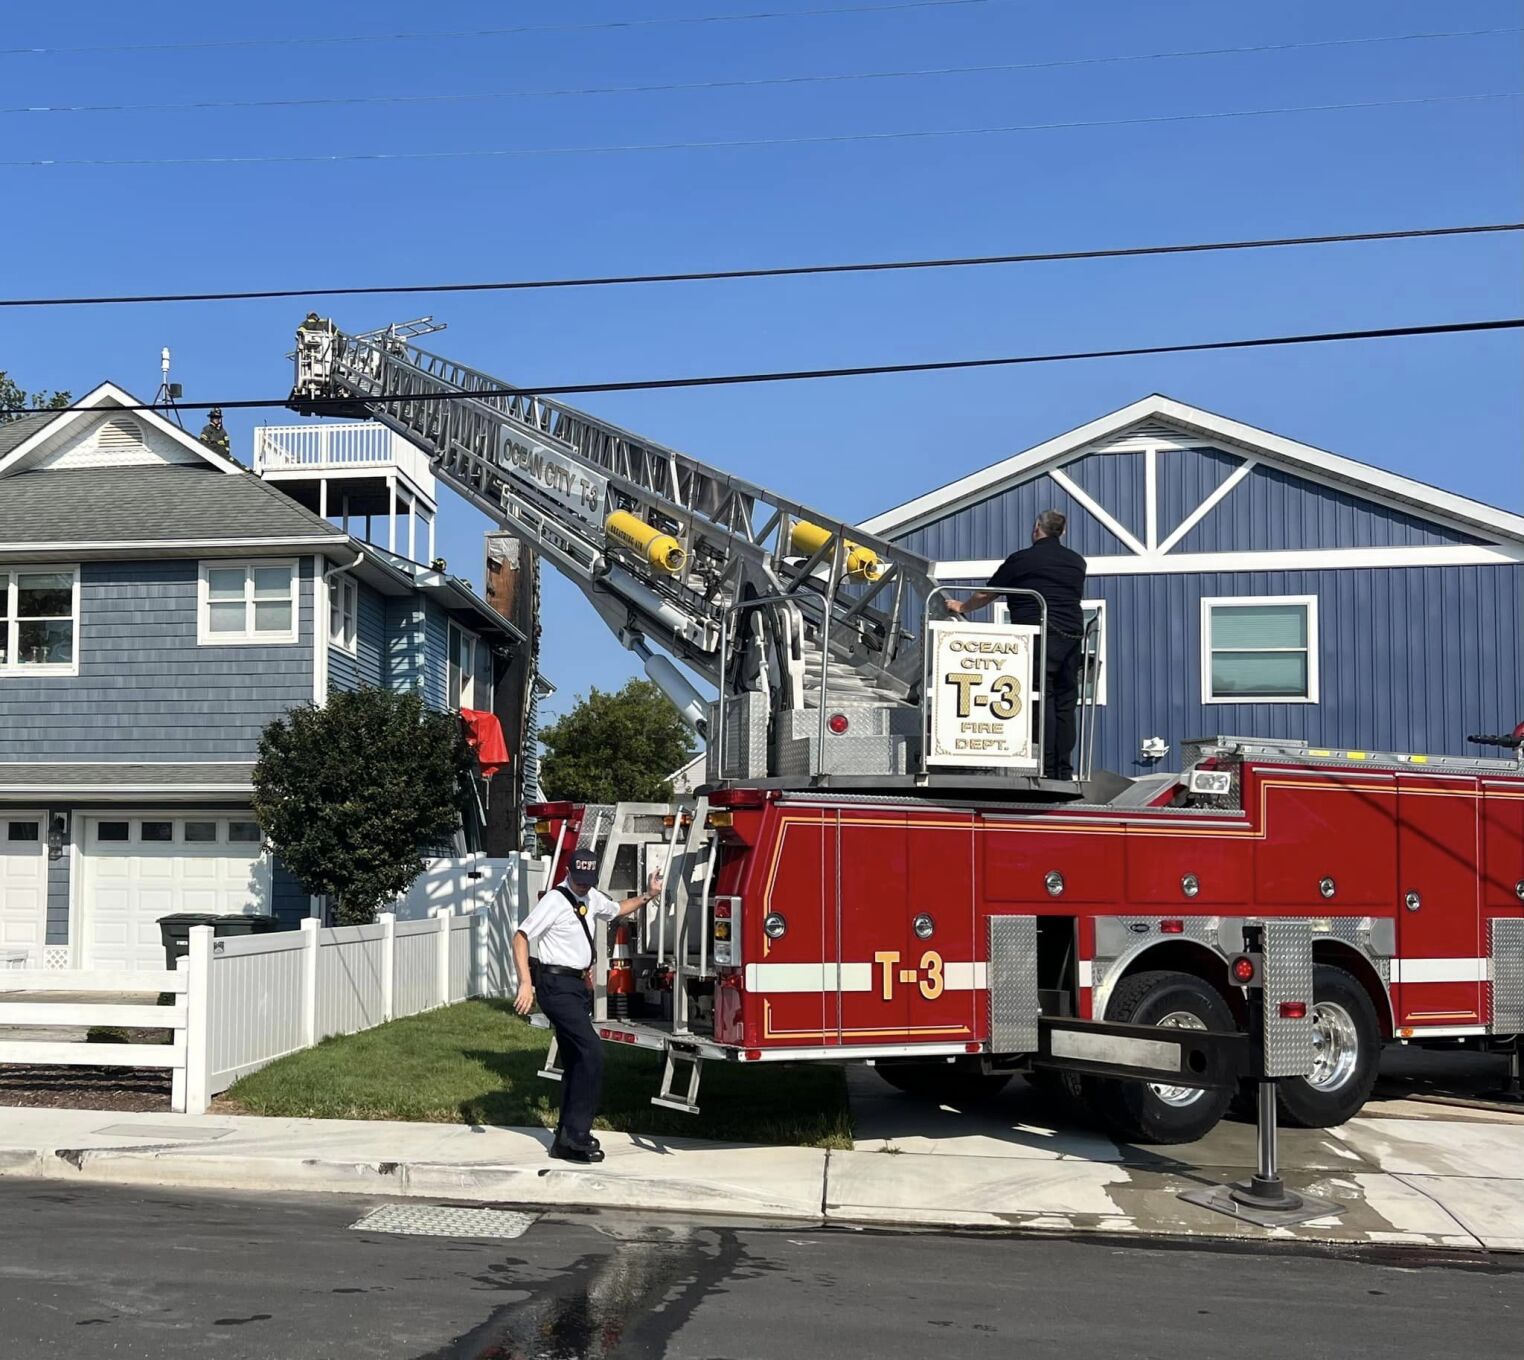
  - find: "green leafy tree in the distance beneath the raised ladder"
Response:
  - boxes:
[539,680,693,803]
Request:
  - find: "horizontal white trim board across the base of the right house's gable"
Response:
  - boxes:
[931,543,1524,581]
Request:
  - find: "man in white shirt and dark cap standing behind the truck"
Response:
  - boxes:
[514,851,661,1162]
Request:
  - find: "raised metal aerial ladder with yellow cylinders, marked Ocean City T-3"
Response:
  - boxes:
[290,314,975,785]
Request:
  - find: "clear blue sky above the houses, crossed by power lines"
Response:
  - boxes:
[0,0,1524,716]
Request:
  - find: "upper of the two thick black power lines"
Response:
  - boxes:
[0,223,1524,306]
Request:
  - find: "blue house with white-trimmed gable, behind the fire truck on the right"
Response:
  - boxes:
[864,396,1524,775]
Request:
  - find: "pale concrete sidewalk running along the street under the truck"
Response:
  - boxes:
[0,1108,1524,1252]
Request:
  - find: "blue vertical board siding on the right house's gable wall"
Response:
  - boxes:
[887,448,1524,775]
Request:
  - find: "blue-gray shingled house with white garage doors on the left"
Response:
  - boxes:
[0,383,523,968]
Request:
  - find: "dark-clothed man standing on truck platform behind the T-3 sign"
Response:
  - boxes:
[948,511,1085,779]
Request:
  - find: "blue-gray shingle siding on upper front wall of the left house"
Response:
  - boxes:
[0,558,312,761]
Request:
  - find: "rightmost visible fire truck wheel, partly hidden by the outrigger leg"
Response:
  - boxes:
[1279,964,1381,1128]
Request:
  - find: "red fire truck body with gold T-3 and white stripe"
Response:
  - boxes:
[536,738,1524,1142]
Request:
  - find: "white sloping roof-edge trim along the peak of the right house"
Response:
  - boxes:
[863,393,1524,543]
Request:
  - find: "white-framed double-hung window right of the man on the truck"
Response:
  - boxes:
[1201,595,1318,703]
